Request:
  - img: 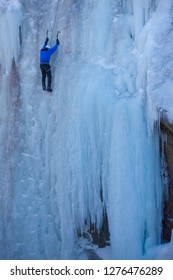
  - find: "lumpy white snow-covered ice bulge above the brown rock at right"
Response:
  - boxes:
[138,0,173,122]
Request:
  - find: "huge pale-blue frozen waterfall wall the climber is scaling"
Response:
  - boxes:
[0,0,170,259]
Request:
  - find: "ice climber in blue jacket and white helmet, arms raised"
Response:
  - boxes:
[40,34,59,92]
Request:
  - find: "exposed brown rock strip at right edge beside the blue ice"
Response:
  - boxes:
[160,119,173,241]
